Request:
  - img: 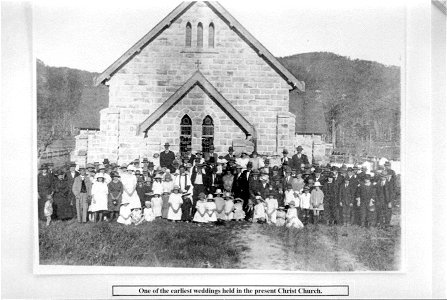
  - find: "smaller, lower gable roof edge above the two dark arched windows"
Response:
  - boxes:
[137,71,256,138]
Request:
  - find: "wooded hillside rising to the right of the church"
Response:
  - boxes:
[280,52,400,157]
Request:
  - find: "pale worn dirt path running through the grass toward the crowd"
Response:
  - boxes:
[239,224,290,270]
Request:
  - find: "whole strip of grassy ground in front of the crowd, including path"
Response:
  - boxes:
[39,216,401,271]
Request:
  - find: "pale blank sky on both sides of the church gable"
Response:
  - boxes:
[33,0,405,72]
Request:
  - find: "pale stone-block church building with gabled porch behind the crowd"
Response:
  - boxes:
[72,1,324,163]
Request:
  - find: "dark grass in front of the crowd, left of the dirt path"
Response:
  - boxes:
[39,220,247,268]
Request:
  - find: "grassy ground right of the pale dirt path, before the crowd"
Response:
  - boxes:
[260,224,400,271]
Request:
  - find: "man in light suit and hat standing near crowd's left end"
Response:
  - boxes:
[72,166,92,223]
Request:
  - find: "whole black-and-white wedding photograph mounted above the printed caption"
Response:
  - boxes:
[33,1,404,272]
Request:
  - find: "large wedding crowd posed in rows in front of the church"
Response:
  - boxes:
[38,143,397,228]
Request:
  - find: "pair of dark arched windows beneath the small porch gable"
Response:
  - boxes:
[180,115,214,156]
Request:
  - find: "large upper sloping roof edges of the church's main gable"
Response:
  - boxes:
[96,1,305,91]
